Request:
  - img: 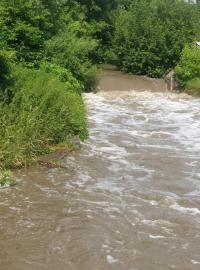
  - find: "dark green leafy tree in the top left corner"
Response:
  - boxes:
[0,0,46,67]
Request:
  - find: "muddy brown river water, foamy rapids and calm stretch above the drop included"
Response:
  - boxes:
[0,70,200,270]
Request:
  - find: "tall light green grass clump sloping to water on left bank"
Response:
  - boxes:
[0,66,87,169]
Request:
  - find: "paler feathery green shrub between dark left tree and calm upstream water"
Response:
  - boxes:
[46,27,97,90]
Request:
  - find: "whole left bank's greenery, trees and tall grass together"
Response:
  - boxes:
[0,0,97,168]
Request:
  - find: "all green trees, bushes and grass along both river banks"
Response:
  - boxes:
[0,0,200,169]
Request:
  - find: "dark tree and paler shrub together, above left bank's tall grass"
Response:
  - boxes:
[0,0,98,87]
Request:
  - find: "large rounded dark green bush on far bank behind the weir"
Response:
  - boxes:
[111,0,200,77]
